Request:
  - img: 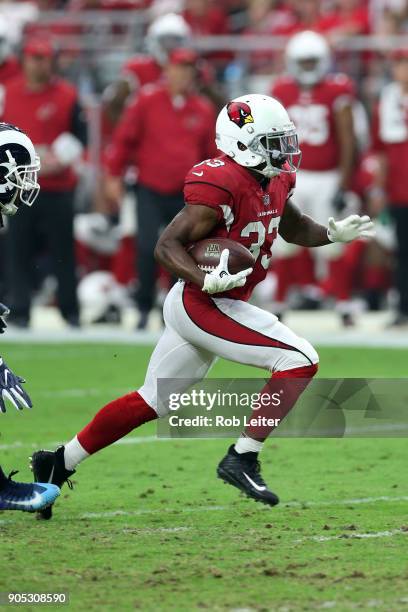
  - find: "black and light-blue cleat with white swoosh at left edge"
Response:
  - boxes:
[0,468,60,512]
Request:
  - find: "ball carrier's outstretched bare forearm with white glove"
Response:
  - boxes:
[279,199,375,247]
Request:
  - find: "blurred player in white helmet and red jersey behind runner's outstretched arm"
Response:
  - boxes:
[272,31,357,323]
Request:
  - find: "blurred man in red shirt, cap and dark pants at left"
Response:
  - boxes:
[3,39,87,327]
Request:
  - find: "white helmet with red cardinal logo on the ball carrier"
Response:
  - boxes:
[215,94,301,178]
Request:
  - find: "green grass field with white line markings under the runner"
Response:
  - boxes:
[0,344,408,612]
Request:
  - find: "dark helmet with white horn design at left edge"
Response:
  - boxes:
[0,123,40,215]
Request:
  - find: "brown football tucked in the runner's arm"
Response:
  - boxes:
[188,238,255,274]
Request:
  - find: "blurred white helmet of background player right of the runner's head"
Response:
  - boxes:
[286,30,331,86]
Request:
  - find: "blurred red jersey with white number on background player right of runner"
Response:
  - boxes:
[271,73,355,171]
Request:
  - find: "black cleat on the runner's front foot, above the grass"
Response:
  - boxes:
[217,445,279,506]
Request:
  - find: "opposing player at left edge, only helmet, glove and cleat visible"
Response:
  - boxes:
[0,123,60,512]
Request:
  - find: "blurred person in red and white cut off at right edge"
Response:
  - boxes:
[371,46,408,327]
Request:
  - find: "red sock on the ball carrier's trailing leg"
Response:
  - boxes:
[77,392,157,455]
